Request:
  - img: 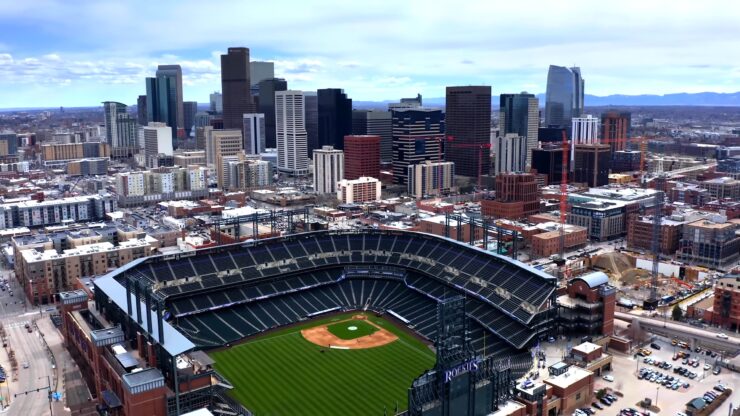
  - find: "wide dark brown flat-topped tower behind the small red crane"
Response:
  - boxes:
[445,86,492,178]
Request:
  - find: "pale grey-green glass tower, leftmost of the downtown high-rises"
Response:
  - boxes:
[103,101,139,159]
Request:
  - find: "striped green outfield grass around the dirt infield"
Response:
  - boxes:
[211,313,434,416]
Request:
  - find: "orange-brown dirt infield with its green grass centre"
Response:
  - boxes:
[301,315,398,350]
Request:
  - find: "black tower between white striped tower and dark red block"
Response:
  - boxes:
[316,88,352,152]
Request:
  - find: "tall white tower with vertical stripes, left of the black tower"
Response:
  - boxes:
[274,90,308,175]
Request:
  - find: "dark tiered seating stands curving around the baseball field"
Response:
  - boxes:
[86,230,557,410]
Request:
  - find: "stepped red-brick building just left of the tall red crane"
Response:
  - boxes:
[481,173,540,220]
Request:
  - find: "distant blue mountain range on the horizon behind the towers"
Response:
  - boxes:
[353,92,740,108]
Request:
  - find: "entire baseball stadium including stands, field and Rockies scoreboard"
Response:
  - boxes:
[85,230,556,415]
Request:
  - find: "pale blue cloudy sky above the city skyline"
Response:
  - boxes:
[0,0,740,108]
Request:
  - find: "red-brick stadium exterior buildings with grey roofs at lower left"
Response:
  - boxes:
[59,290,214,416]
